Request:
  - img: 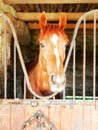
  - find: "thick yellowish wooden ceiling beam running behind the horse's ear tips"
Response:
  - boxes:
[14,12,98,21]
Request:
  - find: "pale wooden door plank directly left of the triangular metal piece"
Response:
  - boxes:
[11,104,25,130]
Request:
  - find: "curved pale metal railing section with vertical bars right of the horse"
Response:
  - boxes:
[64,9,98,101]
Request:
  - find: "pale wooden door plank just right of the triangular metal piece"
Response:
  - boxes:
[60,105,72,130]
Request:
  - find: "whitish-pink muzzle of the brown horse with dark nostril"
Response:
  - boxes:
[49,73,66,92]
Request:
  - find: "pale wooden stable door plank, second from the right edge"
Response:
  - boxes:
[83,105,93,130]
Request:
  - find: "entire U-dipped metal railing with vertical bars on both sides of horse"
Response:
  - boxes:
[0,10,98,101]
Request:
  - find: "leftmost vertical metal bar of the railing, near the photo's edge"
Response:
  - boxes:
[3,18,7,99]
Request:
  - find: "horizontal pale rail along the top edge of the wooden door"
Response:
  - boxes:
[0,99,98,107]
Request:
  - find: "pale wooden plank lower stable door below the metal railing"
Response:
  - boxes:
[0,100,98,130]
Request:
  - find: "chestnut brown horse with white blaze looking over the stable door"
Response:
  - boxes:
[27,13,68,98]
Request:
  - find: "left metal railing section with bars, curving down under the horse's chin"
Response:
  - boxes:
[0,14,57,99]
